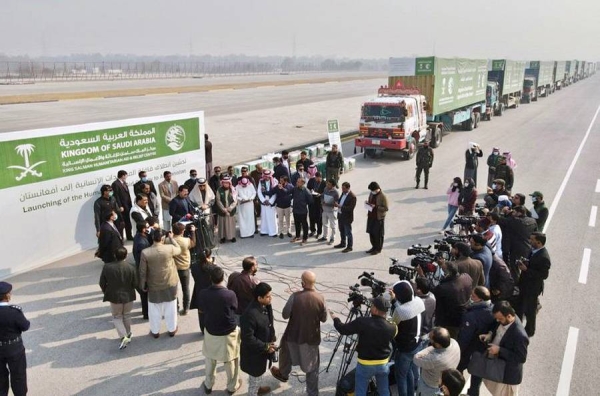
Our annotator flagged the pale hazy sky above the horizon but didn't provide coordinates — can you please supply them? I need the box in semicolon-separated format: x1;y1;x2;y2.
0;0;600;60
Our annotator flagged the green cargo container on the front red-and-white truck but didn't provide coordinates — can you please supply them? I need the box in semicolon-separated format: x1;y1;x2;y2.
388;56;488;116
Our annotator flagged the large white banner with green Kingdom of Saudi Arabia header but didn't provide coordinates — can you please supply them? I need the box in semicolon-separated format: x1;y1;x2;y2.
0;112;206;279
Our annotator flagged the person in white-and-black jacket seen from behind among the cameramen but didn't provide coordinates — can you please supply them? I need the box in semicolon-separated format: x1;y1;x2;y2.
390;280;425;396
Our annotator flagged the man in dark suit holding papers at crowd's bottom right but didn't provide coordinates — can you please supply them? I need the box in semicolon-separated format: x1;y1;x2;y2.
479;301;529;395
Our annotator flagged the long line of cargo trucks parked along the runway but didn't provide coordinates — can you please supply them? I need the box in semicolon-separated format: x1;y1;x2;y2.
354;57;596;159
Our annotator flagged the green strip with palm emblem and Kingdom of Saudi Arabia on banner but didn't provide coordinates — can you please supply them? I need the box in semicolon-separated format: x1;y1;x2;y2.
0;118;200;189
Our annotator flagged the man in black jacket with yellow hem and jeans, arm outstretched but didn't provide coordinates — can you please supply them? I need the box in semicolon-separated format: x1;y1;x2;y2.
329;296;398;396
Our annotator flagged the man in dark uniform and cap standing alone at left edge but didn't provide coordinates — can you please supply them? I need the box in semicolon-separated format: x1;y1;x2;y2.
0;282;29;396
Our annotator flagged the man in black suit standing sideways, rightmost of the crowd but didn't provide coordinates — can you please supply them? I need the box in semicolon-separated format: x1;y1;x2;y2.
516;231;550;337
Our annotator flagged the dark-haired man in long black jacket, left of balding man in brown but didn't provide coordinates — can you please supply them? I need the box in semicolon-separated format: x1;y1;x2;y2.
240;282;276;396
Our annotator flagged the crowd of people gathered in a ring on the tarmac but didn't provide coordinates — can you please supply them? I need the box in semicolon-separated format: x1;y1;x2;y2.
48;136;550;396
